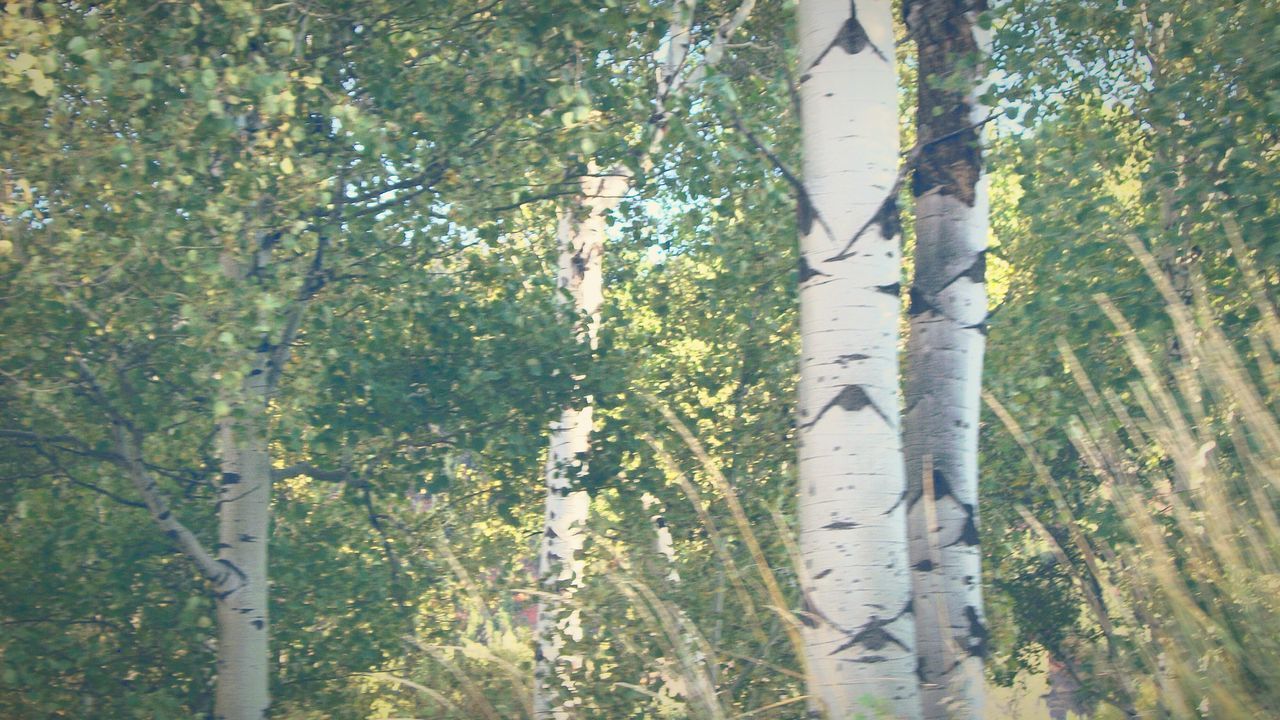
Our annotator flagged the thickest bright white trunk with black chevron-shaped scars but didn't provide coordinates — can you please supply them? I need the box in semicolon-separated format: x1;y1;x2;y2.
796;0;920;720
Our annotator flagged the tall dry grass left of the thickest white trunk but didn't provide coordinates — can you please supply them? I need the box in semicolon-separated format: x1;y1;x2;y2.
364;397;808;720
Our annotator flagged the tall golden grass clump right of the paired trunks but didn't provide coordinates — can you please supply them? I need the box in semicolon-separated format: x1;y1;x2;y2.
986;228;1280;719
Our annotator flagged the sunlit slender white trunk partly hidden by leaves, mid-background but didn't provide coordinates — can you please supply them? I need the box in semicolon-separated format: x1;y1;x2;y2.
534;169;630;719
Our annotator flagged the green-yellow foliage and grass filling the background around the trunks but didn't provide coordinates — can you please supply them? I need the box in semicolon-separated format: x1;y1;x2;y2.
0;0;1280;719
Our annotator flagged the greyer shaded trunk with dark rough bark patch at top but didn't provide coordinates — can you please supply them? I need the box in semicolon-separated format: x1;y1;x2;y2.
904;0;988;720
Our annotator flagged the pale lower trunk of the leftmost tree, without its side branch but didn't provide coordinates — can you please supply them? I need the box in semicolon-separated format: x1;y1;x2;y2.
214;351;271;720
